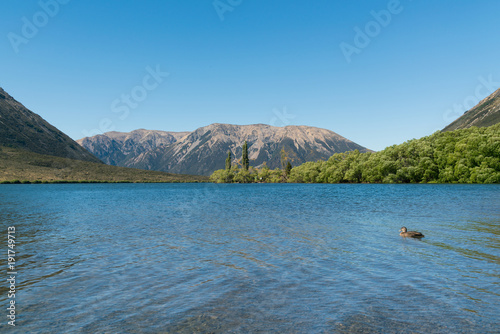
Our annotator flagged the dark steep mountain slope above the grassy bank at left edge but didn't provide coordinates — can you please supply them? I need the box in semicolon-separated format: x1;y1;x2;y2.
0;88;101;162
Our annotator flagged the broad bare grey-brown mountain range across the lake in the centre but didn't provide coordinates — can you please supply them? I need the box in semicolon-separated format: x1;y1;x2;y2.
78;124;368;175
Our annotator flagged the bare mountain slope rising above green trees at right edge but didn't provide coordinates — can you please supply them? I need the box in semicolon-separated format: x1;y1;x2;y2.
443;89;500;131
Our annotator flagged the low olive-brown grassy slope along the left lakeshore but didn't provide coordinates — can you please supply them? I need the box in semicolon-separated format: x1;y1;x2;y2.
0;146;208;183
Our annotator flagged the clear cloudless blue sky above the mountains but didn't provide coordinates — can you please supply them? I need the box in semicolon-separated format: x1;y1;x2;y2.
0;0;500;150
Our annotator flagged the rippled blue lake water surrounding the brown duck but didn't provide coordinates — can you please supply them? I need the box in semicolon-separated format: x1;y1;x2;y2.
0;184;500;333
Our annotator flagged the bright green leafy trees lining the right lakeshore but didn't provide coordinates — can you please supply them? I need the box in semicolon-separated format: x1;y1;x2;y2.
210;124;500;183
